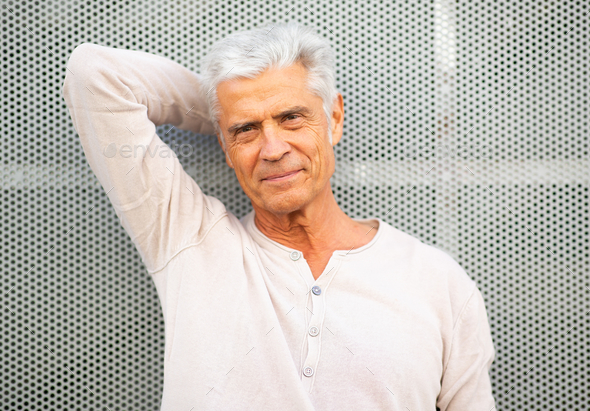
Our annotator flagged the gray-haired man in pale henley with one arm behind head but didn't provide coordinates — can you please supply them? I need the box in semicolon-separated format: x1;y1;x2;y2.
64;23;494;411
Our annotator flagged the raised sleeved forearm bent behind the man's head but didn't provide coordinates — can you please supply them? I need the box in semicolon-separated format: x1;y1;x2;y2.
63;43;214;134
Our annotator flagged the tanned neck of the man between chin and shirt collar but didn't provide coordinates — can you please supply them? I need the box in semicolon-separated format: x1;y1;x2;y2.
254;183;358;255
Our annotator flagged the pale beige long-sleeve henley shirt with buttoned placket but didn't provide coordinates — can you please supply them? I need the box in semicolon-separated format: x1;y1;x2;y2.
63;44;494;411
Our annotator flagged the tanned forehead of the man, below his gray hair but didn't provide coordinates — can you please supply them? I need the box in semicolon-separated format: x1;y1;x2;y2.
217;63;321;124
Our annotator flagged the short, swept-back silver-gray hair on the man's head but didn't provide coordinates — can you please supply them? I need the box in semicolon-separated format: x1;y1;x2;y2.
202;21;337;148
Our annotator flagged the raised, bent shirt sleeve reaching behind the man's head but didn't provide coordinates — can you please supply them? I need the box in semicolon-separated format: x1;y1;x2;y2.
63;43;225;273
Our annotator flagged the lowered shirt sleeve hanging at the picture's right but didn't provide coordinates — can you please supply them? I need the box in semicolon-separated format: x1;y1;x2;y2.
436;286;495;411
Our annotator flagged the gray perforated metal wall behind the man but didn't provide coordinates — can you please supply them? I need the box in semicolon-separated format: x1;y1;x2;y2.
0;0;590;411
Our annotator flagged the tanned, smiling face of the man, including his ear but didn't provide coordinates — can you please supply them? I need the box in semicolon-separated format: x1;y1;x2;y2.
217;64;344;215
